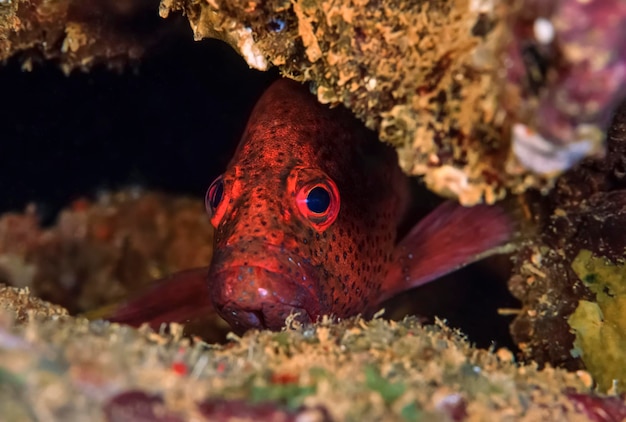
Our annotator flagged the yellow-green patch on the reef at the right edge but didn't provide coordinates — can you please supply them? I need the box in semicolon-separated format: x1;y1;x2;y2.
568;249;626;391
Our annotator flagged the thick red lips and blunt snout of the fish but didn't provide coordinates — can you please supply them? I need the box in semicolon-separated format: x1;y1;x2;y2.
209;244;321;331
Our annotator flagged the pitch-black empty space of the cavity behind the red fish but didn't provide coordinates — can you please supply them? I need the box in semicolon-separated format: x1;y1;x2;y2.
0;24;516;347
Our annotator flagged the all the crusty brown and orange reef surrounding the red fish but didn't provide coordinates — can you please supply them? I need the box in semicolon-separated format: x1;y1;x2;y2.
0;0;626;421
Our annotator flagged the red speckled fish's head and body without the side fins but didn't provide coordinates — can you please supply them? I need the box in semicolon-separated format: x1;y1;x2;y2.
200;81;400;331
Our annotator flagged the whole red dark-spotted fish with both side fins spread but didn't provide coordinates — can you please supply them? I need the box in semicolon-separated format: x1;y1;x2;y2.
109;79;514;331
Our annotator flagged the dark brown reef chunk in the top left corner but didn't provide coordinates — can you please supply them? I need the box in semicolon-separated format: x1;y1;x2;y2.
0;0;171;73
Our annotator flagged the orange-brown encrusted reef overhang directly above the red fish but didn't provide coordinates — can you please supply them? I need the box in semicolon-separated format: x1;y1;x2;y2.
161;0;507;203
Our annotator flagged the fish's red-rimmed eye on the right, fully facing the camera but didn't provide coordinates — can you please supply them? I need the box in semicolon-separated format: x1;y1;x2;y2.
296;179;339;231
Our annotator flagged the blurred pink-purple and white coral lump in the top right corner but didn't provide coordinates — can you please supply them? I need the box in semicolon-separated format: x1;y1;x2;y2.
502;0;626;173
